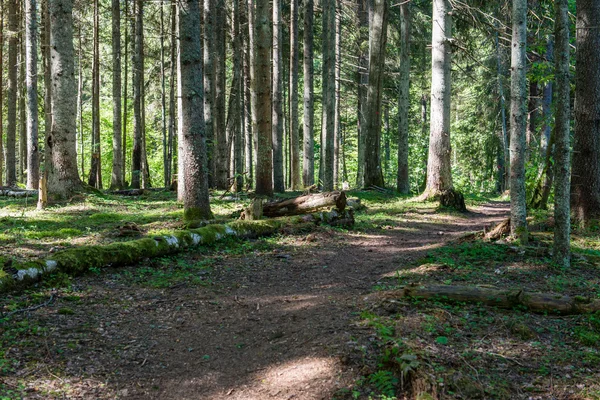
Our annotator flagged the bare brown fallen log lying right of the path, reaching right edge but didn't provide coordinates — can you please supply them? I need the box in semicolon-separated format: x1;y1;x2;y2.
384;284;600;315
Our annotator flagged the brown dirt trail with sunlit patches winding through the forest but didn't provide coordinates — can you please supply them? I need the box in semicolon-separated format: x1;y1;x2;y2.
5;203;508;400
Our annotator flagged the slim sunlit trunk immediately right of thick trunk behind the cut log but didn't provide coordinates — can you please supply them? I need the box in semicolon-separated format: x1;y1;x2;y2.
271;0;285;193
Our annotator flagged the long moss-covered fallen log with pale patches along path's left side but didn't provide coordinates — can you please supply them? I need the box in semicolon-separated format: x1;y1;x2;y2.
0;211;354;293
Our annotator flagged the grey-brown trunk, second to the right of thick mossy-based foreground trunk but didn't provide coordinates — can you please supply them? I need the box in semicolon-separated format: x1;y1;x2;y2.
213;0;229;189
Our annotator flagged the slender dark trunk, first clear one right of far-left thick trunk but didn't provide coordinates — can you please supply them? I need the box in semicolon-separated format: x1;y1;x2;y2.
88;0;102;189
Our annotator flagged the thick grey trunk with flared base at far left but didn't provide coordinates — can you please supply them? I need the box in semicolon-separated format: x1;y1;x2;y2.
47;0;81;200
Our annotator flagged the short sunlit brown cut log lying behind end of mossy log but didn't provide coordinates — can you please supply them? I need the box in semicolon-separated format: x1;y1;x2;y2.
263;192;346;218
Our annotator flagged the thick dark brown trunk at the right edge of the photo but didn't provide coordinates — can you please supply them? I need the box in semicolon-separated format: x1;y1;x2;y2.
571;0;600;227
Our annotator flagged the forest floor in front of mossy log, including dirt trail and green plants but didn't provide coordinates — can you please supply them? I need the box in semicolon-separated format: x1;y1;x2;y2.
0;193;600;400
